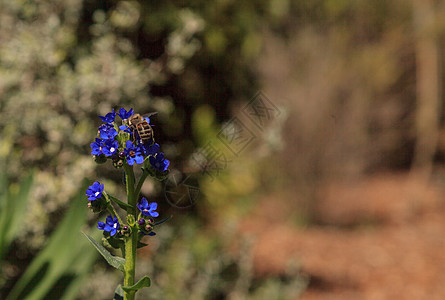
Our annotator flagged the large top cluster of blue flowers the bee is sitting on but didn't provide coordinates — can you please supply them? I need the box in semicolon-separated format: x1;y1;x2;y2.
90;108;170;172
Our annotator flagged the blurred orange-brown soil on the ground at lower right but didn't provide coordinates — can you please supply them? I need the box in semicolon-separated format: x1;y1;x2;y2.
240;175;445;300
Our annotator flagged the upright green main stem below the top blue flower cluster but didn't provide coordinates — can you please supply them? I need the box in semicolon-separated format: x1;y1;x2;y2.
124;162;137;300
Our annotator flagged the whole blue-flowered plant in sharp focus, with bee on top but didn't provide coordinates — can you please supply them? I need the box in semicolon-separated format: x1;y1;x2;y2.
85;108;170;300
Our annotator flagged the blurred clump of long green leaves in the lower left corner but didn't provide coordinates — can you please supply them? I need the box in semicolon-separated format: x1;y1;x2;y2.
0;173;98;300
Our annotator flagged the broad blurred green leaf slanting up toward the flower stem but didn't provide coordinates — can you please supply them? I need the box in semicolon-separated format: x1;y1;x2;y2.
6;182;100;300
